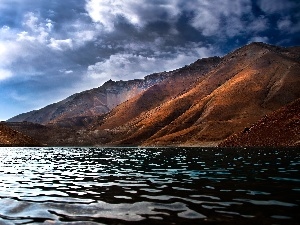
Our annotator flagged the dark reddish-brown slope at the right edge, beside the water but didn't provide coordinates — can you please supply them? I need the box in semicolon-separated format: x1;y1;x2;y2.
219;99;300;147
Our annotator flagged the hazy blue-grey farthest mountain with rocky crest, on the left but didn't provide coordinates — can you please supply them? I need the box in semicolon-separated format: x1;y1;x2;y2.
7;72;169;124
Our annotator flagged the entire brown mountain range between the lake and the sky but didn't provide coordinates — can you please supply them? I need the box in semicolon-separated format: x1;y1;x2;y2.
2;43;300;147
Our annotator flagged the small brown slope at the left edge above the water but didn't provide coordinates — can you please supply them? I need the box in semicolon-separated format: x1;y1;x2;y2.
0;123;41;147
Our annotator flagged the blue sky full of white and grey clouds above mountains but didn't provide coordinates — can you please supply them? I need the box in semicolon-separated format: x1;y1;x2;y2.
0;0;300;120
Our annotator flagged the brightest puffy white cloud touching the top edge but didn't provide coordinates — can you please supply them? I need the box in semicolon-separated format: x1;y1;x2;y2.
86;0;181;31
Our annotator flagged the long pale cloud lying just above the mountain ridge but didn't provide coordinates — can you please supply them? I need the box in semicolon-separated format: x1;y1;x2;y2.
87;44;213;81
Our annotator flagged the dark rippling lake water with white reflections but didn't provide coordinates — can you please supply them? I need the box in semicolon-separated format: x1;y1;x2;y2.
0;148;300;225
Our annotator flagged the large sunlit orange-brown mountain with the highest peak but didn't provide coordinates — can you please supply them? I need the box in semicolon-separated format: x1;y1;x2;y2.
92;43;300;145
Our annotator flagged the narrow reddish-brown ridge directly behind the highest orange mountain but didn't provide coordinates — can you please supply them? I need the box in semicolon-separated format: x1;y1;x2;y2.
94;57;220;129
